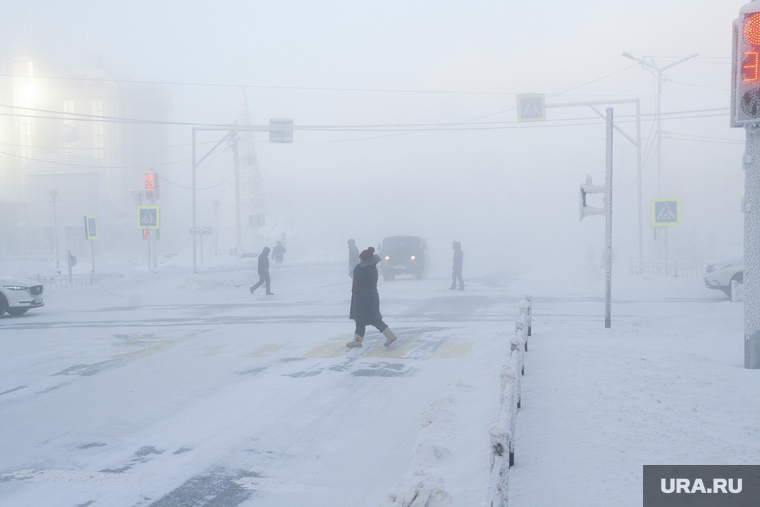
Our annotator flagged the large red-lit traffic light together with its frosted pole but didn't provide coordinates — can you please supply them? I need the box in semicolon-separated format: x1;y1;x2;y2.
731;2;760;369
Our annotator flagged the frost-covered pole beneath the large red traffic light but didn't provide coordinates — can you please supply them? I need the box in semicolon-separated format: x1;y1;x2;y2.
744;123;760;369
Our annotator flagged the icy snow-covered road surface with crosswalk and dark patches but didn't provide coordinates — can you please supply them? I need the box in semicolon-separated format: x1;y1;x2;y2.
0;265;522;507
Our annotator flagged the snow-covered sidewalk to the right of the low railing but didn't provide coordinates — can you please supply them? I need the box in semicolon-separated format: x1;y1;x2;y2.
509;279;760;507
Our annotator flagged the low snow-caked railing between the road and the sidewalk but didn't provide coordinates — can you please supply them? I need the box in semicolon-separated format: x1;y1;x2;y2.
485;296;533;507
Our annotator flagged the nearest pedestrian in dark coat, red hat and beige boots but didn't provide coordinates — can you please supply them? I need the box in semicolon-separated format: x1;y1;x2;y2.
346;247;396;347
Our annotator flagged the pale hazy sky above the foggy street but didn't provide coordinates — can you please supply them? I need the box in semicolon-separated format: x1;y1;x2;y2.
0;0;745;276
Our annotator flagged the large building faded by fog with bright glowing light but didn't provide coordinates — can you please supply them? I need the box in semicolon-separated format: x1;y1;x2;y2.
0;40;170;266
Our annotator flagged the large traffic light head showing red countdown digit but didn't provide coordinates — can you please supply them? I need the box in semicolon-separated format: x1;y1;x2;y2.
731;7;760;127
